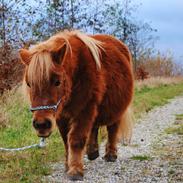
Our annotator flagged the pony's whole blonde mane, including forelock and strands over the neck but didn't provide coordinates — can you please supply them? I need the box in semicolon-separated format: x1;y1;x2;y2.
27;31;103;88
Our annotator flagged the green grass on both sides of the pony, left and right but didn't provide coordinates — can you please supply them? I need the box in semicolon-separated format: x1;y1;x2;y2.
0;80;183;183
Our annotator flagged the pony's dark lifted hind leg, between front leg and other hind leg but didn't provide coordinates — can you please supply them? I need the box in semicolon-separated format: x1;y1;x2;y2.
87;127;99;160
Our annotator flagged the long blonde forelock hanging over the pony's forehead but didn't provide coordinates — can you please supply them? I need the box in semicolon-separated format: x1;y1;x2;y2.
27;51;52;90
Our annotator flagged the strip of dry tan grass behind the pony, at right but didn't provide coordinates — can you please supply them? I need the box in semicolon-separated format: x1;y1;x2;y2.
135;77;183;91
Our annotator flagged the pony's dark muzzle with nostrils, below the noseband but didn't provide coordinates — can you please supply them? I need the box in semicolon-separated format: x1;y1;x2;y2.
33;119;52;137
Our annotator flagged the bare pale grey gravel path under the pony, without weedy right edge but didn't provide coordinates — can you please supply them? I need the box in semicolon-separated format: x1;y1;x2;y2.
46;96;183;183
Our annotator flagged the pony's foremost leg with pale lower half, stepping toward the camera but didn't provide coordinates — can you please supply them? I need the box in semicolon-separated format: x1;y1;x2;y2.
67;103;96;180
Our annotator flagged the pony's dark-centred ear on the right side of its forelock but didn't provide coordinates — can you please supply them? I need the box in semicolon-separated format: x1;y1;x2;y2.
51;44;67;64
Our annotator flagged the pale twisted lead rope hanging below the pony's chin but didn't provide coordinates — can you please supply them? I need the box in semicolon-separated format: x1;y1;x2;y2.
0;138;46;152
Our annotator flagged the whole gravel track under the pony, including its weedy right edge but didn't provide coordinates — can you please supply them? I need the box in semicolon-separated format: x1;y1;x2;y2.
44;97;183;183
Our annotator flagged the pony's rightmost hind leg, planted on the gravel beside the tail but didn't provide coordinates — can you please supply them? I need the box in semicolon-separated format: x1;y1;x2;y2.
104;123;120;162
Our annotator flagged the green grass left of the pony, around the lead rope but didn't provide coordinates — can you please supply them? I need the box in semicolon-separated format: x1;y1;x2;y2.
0;89;64;183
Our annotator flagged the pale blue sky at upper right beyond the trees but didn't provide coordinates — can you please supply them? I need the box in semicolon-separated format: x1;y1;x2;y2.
133;0;183;62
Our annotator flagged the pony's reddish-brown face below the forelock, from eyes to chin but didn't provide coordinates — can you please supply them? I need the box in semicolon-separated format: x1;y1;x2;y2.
25;71;65;137
